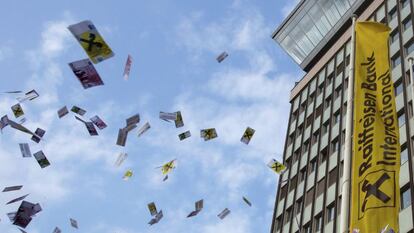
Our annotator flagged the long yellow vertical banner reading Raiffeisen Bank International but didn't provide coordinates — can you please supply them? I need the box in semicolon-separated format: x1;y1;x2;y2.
350;22;400;233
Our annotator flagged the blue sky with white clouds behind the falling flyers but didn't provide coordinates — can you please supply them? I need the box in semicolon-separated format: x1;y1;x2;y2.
0;0;302;233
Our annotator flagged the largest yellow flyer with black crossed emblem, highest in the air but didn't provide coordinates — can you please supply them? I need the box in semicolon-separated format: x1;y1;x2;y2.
68;20;114;64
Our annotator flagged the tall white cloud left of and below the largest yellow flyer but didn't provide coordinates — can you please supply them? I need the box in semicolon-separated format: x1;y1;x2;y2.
0;14;116;208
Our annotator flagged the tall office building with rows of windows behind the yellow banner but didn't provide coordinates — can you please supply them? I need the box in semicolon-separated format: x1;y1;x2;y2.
271;0;414;233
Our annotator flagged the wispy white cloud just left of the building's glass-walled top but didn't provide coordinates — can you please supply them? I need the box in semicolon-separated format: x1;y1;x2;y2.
176;8;271;64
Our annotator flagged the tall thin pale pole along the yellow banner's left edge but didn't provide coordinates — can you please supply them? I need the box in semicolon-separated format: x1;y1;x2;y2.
339;15;356;233
